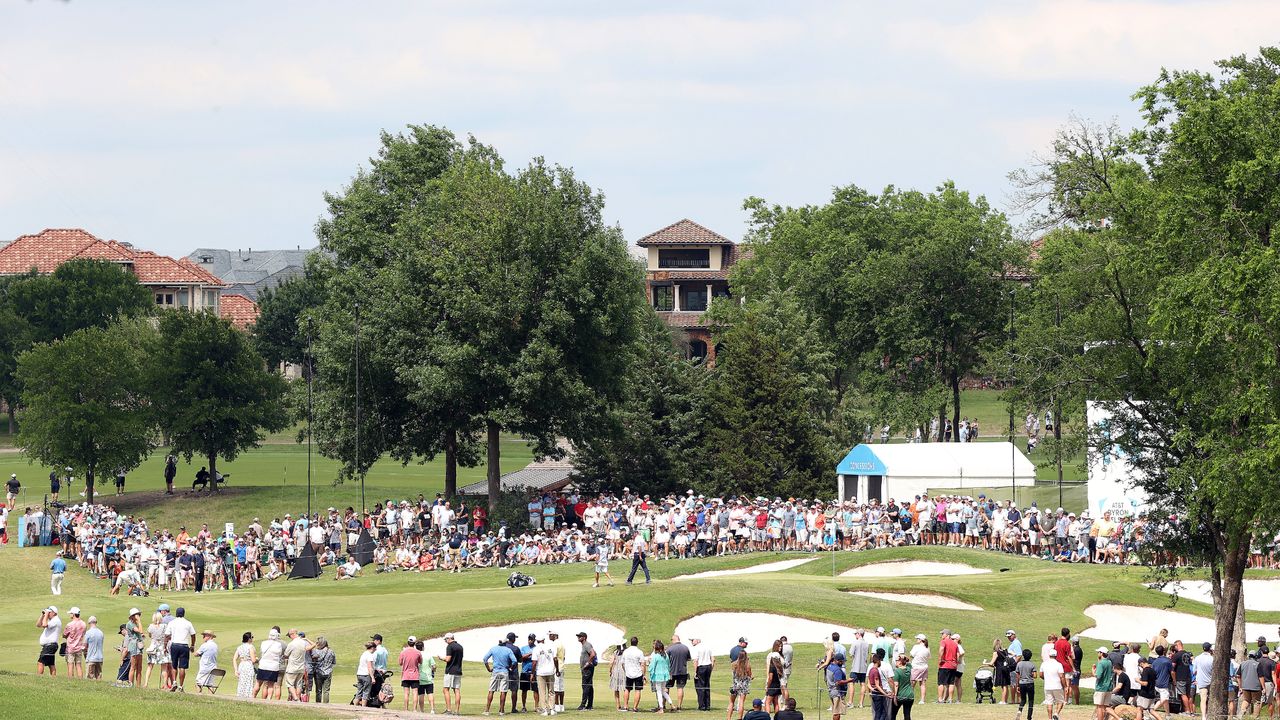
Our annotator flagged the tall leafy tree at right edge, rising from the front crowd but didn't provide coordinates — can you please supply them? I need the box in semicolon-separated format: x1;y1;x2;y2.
1018;47;1280;716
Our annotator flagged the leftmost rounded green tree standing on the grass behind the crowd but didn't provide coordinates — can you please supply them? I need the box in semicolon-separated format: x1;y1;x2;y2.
18;323;155;502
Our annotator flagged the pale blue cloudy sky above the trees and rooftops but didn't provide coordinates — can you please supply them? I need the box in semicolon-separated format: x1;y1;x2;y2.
0;0;1280;255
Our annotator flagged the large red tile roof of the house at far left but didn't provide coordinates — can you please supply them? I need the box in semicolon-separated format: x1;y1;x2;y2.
0;228;223;287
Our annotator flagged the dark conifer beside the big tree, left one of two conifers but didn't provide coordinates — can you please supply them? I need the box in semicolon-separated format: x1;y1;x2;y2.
573;307;710;496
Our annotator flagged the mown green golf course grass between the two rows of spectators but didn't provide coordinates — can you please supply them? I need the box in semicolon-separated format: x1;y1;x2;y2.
0;538;1264;720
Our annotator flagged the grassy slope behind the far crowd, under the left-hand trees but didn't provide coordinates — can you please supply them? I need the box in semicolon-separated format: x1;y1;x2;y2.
0;433;531;532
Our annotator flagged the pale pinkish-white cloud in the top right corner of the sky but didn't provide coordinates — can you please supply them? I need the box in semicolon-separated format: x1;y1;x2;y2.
888;0;1280;85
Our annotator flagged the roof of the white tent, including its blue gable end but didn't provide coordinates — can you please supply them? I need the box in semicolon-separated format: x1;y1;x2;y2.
836;442;1036;478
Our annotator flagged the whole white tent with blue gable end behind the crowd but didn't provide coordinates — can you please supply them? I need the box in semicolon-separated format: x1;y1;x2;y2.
836;442;1036;502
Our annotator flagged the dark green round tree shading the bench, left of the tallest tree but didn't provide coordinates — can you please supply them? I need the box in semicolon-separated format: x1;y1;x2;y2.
150;310;288;491
